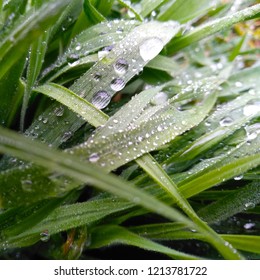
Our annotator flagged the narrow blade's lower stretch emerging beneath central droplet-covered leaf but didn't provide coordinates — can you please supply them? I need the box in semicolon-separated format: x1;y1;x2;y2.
136;154;242;258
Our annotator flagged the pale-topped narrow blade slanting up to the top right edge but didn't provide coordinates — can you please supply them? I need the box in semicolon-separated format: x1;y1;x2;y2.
167;4;260;54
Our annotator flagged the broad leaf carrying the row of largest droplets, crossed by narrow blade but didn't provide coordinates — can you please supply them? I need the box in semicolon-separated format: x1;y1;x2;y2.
19;22;179;150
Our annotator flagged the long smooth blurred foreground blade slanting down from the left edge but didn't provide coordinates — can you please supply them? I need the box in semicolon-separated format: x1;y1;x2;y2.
0;128;196;227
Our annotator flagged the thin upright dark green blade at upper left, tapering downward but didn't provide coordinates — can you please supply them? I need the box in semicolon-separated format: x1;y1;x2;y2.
20;31;50;131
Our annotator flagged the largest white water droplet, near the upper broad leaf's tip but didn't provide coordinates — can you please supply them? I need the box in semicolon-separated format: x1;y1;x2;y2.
139;37;163;61
